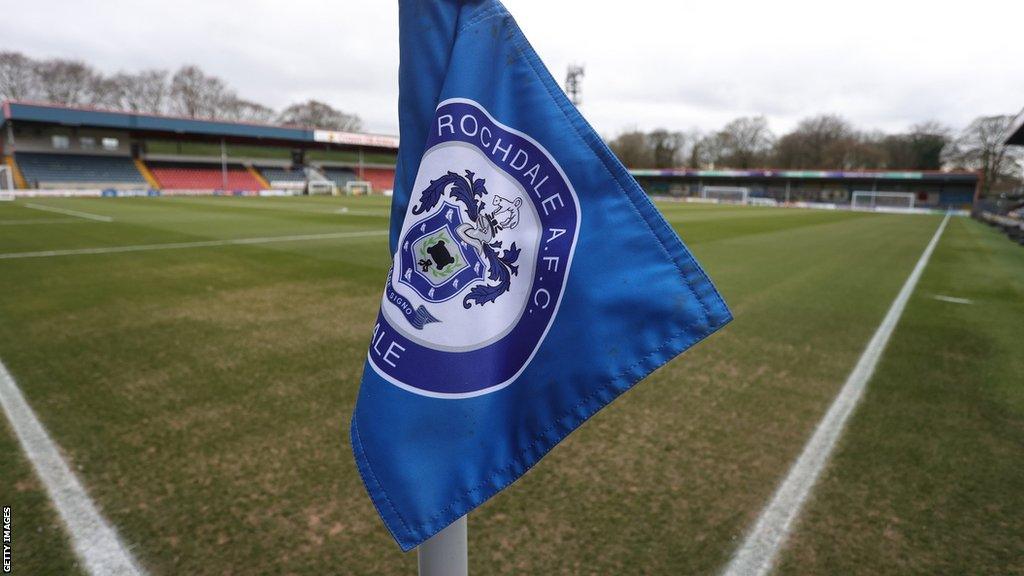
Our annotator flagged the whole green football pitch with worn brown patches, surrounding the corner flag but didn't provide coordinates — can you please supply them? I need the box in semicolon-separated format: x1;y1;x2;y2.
0;197;1024;575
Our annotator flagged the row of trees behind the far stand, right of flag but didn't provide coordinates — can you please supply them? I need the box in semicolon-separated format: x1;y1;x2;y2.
608;115;1024;192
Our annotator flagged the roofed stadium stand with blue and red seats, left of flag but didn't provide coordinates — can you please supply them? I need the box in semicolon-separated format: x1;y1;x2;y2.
0;100;398;195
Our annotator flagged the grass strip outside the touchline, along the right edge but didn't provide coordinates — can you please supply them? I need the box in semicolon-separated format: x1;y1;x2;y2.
781;219;1024;574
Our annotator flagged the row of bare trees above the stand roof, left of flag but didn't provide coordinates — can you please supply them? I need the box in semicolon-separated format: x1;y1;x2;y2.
0;51;362;131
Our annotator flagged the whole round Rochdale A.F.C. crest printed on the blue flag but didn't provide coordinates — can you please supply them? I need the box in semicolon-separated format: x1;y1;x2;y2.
370;99;580;398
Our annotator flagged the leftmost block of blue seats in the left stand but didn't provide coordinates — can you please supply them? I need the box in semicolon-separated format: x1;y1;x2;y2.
14;152;148;188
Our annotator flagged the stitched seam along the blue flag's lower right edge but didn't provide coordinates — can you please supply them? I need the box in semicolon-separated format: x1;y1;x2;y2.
417;319;715;525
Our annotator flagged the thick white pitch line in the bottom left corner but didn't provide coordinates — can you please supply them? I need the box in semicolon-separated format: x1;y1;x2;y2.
0;362;145;576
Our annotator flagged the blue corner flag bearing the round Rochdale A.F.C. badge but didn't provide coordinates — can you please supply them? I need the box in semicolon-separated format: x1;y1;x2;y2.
351;0;731;550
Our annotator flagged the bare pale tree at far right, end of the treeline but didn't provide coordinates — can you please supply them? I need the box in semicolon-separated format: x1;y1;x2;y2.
942;116;1024;195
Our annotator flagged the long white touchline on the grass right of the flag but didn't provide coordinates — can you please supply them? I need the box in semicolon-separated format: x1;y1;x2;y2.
723;213;949;576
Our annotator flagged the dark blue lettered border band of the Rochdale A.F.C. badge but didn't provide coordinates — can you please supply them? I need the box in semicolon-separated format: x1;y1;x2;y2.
368;98;580;399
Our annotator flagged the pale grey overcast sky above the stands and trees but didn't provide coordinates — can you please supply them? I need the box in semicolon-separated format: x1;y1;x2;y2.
0;0;1024;135
